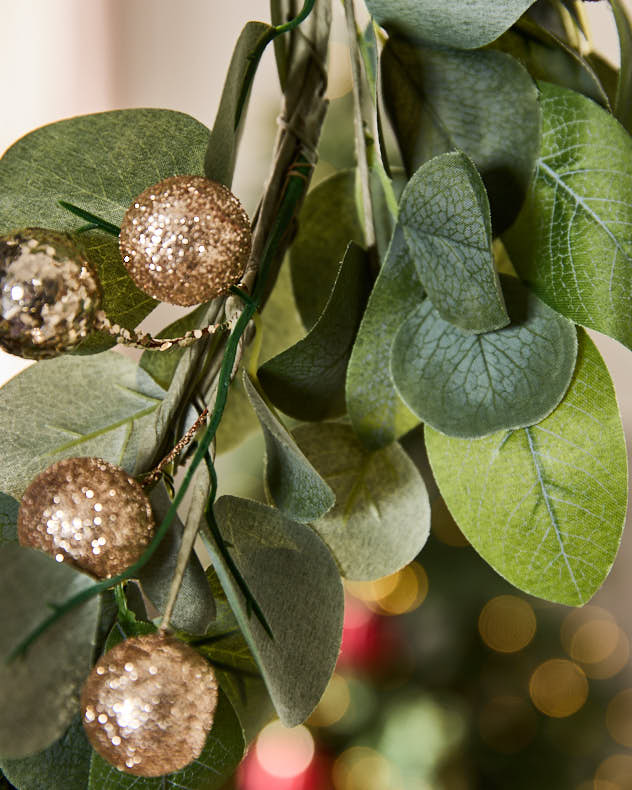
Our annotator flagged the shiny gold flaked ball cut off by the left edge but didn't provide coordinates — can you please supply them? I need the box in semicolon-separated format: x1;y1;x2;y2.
0;228;101;359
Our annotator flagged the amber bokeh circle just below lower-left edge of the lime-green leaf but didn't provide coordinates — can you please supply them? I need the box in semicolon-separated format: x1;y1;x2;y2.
478;595;537;653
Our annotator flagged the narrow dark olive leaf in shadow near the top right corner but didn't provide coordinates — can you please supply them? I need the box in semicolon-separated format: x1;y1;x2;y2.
491;18;610;109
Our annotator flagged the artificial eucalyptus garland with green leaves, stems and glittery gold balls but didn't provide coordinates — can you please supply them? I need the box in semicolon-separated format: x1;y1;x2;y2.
0;0;632;790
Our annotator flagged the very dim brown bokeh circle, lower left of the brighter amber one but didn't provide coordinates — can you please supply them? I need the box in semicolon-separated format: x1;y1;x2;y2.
478;696;538;754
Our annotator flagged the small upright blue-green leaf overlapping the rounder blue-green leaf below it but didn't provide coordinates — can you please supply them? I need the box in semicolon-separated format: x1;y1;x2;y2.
399;152;509;332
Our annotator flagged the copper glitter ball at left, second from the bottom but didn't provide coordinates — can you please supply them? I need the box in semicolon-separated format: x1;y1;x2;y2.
18;458;155;579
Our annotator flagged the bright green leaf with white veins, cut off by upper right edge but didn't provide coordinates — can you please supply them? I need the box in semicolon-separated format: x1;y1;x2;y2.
505;83;632;347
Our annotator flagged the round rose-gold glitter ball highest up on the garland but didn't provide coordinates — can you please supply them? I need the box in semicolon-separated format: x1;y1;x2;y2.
119;176;252;306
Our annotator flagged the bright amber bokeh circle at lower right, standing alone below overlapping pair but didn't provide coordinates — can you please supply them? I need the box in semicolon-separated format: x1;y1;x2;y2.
529;658;588;719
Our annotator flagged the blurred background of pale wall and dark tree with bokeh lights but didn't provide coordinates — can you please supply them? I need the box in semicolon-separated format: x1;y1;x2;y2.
0;0;632;790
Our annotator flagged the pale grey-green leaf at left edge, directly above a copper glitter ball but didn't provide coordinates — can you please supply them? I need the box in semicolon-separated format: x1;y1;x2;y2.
0;351;164;498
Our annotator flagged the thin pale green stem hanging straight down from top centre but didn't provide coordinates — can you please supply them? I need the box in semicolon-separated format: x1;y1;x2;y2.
344;0;377;255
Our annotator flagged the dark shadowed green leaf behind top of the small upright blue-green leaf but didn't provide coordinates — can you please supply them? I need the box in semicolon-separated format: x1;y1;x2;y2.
382;40;540;233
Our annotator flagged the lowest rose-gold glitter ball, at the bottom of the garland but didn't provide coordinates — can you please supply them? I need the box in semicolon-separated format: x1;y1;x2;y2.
81;634;217;776
